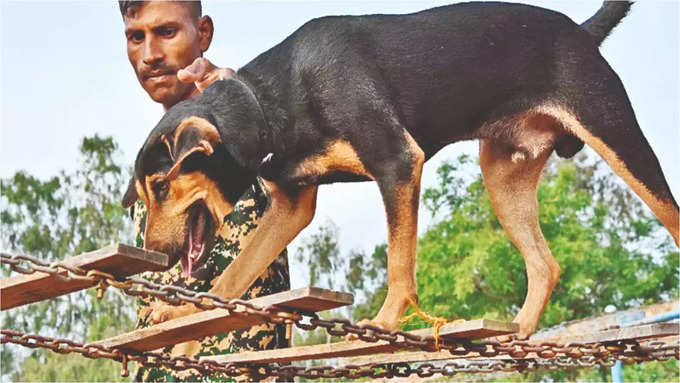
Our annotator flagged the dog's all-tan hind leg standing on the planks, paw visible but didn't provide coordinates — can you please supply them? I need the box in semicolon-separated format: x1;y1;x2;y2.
479;140;560;338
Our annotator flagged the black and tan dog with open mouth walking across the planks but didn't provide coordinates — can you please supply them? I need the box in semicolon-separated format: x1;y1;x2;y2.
124;2;678;337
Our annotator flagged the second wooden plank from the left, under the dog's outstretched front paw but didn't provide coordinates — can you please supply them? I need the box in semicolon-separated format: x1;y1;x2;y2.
97;287;354;351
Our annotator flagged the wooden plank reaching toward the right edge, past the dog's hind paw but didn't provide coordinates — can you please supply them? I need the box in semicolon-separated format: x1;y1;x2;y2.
340;323;680;366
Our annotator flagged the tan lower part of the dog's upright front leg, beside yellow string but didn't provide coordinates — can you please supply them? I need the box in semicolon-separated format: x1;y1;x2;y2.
372;132;425;330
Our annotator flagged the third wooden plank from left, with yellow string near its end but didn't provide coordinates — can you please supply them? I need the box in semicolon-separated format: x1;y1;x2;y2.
202;319;519;363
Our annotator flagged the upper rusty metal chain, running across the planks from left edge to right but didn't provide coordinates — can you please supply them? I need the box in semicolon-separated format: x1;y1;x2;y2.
0;254;680;376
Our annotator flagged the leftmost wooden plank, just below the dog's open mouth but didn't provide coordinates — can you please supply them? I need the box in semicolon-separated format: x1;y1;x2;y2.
0;244;168;310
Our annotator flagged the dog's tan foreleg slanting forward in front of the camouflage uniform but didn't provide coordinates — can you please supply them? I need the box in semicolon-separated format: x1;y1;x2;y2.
210;181;318;299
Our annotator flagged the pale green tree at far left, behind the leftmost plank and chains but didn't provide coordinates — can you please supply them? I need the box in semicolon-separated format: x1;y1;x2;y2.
0;136;135;381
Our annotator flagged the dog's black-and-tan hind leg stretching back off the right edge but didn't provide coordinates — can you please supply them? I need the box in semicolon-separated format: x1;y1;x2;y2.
548;57;680;246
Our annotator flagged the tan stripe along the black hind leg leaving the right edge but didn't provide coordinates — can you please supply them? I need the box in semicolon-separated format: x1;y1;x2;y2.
536;103;680;246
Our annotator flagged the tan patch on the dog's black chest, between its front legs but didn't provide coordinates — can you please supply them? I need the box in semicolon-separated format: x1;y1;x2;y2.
296;140;373;178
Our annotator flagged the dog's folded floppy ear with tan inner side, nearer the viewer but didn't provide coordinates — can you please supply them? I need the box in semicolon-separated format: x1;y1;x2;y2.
161;116;221;179
